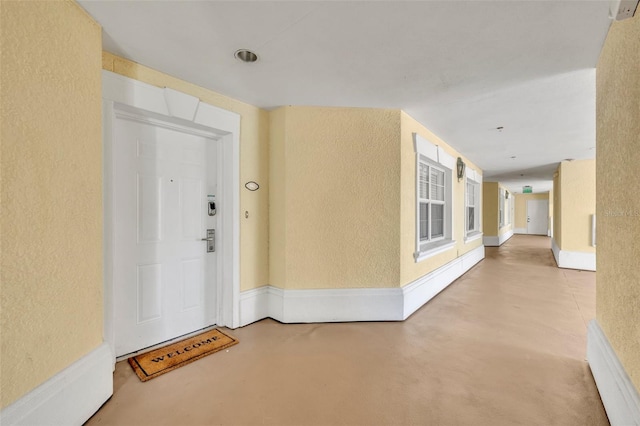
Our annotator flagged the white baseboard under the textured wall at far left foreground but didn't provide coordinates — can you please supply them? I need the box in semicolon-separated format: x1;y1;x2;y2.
0;343;113;426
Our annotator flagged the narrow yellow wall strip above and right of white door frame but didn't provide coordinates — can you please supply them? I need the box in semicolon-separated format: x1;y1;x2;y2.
102;52;269;290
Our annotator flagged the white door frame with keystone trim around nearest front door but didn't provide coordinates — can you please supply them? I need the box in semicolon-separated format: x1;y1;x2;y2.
102;70;240;366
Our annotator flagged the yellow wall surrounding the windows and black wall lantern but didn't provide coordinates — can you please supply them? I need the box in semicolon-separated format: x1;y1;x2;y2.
400;112;482;286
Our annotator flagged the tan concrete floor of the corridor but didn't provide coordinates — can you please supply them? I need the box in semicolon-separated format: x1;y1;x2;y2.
87;235;608;426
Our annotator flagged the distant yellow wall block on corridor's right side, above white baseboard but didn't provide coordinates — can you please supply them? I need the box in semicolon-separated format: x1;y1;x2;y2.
556;160;596;253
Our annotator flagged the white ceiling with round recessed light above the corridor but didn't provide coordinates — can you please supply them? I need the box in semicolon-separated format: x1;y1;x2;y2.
80;0;611;192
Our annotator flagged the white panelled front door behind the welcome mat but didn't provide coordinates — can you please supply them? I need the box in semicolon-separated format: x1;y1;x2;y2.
113;118;219;356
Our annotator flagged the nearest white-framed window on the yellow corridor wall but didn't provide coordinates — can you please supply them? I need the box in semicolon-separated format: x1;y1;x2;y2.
414;134;455;262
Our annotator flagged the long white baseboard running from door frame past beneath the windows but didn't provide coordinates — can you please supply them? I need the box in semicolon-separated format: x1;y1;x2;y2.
240;246;484;326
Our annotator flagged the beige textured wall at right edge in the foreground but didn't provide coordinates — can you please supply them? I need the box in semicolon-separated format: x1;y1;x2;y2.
596;12;640;392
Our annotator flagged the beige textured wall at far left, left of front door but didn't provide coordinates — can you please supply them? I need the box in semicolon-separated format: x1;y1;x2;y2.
0;1;102;407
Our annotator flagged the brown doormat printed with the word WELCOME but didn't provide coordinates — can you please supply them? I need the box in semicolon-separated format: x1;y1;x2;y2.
128;329;238;382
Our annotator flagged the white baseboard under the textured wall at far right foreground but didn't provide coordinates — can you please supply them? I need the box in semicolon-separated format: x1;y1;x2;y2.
587;320;640;426
